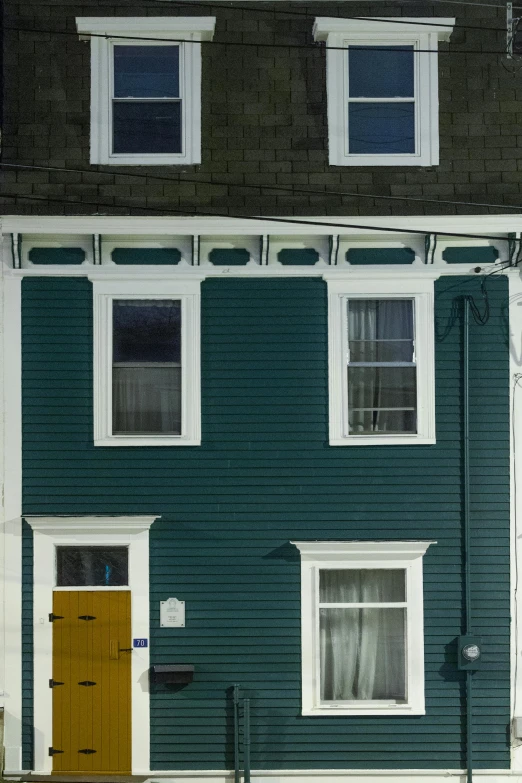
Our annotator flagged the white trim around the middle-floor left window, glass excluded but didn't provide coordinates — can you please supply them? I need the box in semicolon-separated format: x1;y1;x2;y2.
93;278;201;446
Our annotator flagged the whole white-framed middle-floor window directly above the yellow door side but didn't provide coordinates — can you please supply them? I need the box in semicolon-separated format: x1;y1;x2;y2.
94;281;201;446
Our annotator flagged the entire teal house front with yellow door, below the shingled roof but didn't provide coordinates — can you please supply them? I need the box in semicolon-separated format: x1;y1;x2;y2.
3;211;520;782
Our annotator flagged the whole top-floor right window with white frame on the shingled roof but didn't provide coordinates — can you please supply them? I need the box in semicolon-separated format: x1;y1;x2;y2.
314;18;454;166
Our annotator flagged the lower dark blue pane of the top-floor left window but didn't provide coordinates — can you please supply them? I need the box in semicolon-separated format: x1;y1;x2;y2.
112;101;181;154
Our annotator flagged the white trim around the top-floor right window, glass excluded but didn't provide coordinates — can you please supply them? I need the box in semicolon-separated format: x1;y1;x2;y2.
314;17;455;166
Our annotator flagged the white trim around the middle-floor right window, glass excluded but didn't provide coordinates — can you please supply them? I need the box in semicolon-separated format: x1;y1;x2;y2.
325;275;436;446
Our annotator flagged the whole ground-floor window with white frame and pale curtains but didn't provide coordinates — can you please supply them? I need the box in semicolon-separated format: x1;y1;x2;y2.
294;541;430;715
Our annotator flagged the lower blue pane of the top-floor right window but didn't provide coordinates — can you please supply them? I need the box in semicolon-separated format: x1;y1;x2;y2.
348;102;415;155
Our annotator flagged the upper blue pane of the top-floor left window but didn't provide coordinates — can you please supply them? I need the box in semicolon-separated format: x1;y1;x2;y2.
114;46;179;98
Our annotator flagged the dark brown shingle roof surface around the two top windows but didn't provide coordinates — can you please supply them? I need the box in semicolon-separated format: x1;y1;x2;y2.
0;0;522;215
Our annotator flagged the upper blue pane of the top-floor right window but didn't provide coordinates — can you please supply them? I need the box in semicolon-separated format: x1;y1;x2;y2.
348;46;413;98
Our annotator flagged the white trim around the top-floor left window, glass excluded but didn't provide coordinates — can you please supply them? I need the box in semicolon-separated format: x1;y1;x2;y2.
76;16;216;166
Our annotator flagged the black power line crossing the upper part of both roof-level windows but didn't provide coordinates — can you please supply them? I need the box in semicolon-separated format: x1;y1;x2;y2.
4;23;505;56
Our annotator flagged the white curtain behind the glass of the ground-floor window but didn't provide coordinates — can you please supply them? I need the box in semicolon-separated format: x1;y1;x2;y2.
319;570;406;701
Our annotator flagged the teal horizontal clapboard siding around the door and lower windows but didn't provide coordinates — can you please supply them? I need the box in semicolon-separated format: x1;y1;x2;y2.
23;277;509;769
